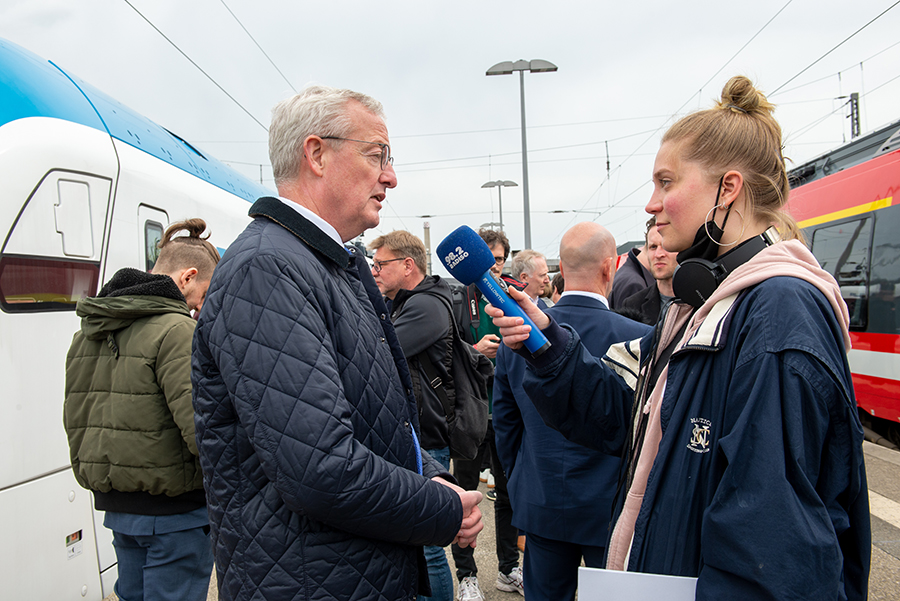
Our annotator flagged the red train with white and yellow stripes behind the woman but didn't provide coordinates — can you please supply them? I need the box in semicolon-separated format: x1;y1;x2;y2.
788;121;900;445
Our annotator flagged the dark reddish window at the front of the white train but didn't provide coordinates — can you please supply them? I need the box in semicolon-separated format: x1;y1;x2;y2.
0;255;100;313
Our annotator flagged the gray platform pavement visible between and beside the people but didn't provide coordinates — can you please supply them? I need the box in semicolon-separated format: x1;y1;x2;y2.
104;442;900;601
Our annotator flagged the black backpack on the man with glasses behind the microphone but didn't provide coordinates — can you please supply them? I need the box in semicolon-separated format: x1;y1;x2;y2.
417;294;494;460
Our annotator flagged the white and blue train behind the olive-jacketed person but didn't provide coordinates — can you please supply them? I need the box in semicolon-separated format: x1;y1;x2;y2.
0;40;272;600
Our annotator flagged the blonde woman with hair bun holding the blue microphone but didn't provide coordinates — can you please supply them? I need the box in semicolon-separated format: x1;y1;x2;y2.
489;77;871;601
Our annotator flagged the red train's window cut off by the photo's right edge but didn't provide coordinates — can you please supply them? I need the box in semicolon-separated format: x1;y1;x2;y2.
868;206;900;334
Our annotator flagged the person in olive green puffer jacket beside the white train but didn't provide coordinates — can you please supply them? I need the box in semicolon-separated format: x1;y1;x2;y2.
63;219;219;601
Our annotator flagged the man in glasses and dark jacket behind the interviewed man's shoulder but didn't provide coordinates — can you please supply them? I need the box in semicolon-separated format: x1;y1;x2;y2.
369;230;453;601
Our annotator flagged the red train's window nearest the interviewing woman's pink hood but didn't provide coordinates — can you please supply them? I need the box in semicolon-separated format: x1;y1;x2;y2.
812;217;872;330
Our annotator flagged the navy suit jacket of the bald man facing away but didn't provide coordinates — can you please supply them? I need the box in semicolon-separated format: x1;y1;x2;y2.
494;294;650;547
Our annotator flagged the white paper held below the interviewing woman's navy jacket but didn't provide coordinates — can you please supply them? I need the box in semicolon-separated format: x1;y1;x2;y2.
578;568;697;601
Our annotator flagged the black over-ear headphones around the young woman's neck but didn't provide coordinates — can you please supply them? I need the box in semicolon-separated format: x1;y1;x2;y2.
672;227;781;307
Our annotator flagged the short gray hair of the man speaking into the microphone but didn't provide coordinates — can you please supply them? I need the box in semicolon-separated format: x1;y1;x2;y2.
269;86;384;185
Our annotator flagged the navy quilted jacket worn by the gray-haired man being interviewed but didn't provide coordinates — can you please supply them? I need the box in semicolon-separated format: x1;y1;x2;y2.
192;198;462;601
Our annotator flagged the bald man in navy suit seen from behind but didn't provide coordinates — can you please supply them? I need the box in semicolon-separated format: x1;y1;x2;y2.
494;222;650;601
